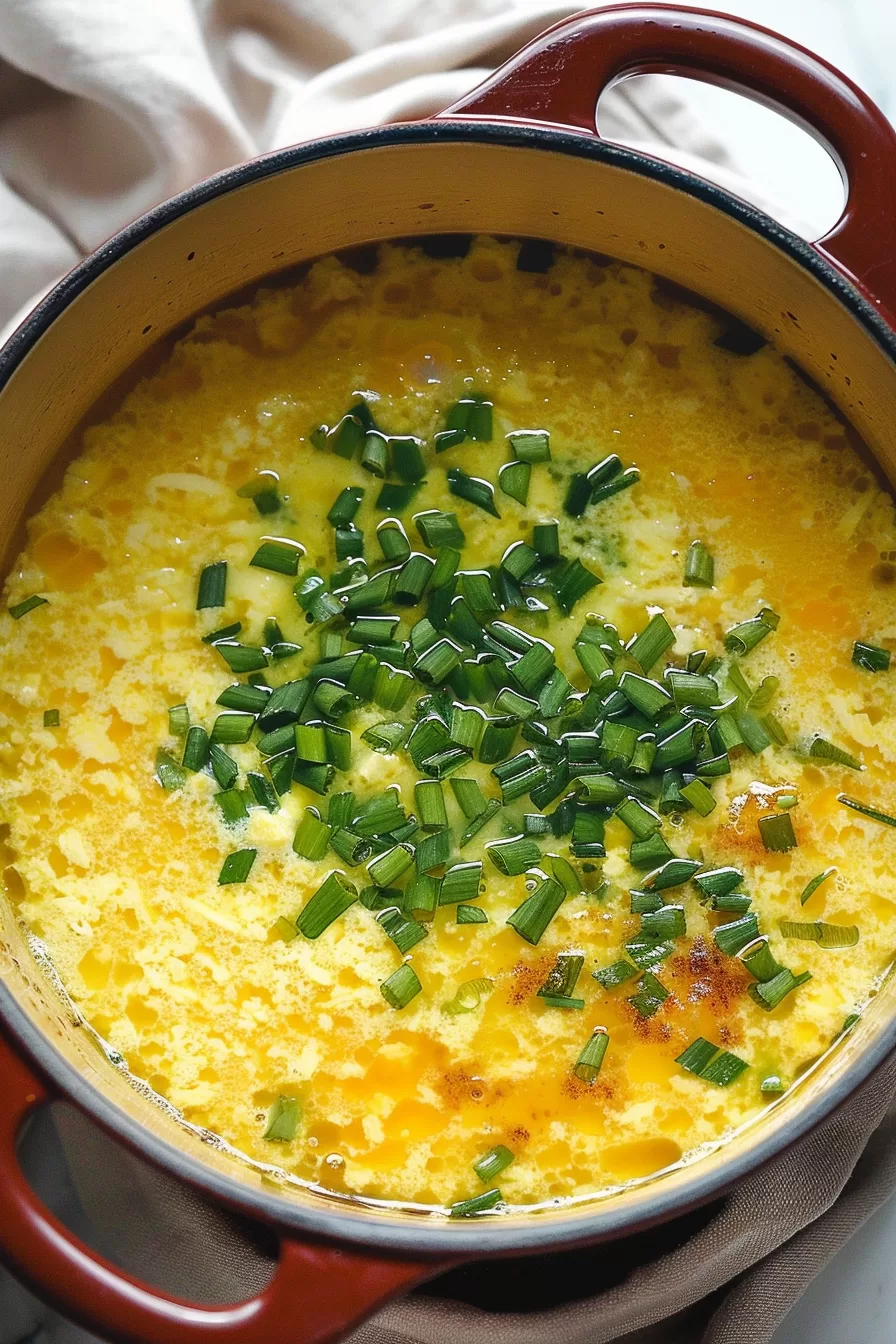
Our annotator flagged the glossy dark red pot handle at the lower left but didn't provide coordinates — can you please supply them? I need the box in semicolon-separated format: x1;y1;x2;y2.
0;1038;435;1344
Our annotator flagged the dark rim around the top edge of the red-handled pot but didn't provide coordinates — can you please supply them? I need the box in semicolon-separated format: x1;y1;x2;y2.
0;120;896;1257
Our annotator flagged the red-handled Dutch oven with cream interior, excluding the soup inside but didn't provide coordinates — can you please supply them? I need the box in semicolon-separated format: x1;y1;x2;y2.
0;4;896;1344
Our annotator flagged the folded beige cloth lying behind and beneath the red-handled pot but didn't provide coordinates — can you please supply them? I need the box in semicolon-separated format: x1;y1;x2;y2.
0;0;896;1344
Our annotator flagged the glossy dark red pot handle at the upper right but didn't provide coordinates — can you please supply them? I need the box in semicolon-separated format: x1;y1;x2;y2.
439;4;896;327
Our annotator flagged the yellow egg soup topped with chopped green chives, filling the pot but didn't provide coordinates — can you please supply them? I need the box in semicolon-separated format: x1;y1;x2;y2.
0;238;896;1216
